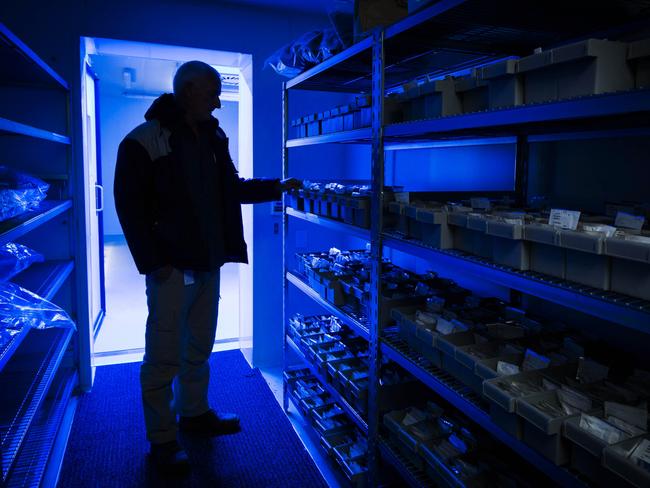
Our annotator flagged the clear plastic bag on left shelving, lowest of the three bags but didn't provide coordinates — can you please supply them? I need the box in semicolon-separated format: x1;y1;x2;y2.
0;282;76;329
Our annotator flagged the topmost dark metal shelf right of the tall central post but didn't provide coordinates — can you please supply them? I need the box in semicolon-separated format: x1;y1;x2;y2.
384;0;650;87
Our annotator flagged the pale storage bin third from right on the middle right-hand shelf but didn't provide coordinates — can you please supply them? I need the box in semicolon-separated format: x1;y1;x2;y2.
524;223;566;279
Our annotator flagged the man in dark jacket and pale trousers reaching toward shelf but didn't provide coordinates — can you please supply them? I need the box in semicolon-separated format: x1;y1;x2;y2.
114;61;300;473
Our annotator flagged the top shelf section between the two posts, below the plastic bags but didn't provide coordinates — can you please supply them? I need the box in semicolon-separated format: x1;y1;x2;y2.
286;37;372;92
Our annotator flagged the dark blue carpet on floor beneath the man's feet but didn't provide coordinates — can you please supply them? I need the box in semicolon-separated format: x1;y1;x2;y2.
58;351;327;488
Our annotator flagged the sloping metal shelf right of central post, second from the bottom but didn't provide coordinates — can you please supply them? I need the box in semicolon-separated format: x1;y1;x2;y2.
381;334;584;486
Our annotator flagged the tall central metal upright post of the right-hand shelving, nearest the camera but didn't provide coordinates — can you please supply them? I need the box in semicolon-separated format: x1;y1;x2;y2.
368;29;384;486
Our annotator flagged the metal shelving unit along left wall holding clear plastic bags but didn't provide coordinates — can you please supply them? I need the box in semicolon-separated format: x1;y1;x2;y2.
0;23;78;487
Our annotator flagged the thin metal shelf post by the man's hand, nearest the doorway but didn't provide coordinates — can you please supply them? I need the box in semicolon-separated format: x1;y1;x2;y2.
282;82;289;412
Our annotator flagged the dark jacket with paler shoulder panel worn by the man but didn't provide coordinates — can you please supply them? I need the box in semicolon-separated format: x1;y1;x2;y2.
114;94;281;274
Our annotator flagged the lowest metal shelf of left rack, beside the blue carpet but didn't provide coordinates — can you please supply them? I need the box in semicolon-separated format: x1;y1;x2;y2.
6;368;78;488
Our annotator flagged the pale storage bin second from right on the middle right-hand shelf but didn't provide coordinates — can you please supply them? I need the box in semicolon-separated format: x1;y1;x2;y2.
558;230;611;290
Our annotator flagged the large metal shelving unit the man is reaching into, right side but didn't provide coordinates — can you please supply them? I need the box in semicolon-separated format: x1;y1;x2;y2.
283;0;650;486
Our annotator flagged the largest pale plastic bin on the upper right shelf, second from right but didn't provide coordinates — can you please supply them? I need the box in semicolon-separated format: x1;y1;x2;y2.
518;39;634;103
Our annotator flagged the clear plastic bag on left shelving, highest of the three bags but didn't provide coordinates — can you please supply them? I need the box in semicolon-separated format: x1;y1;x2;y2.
0;166;50;221
